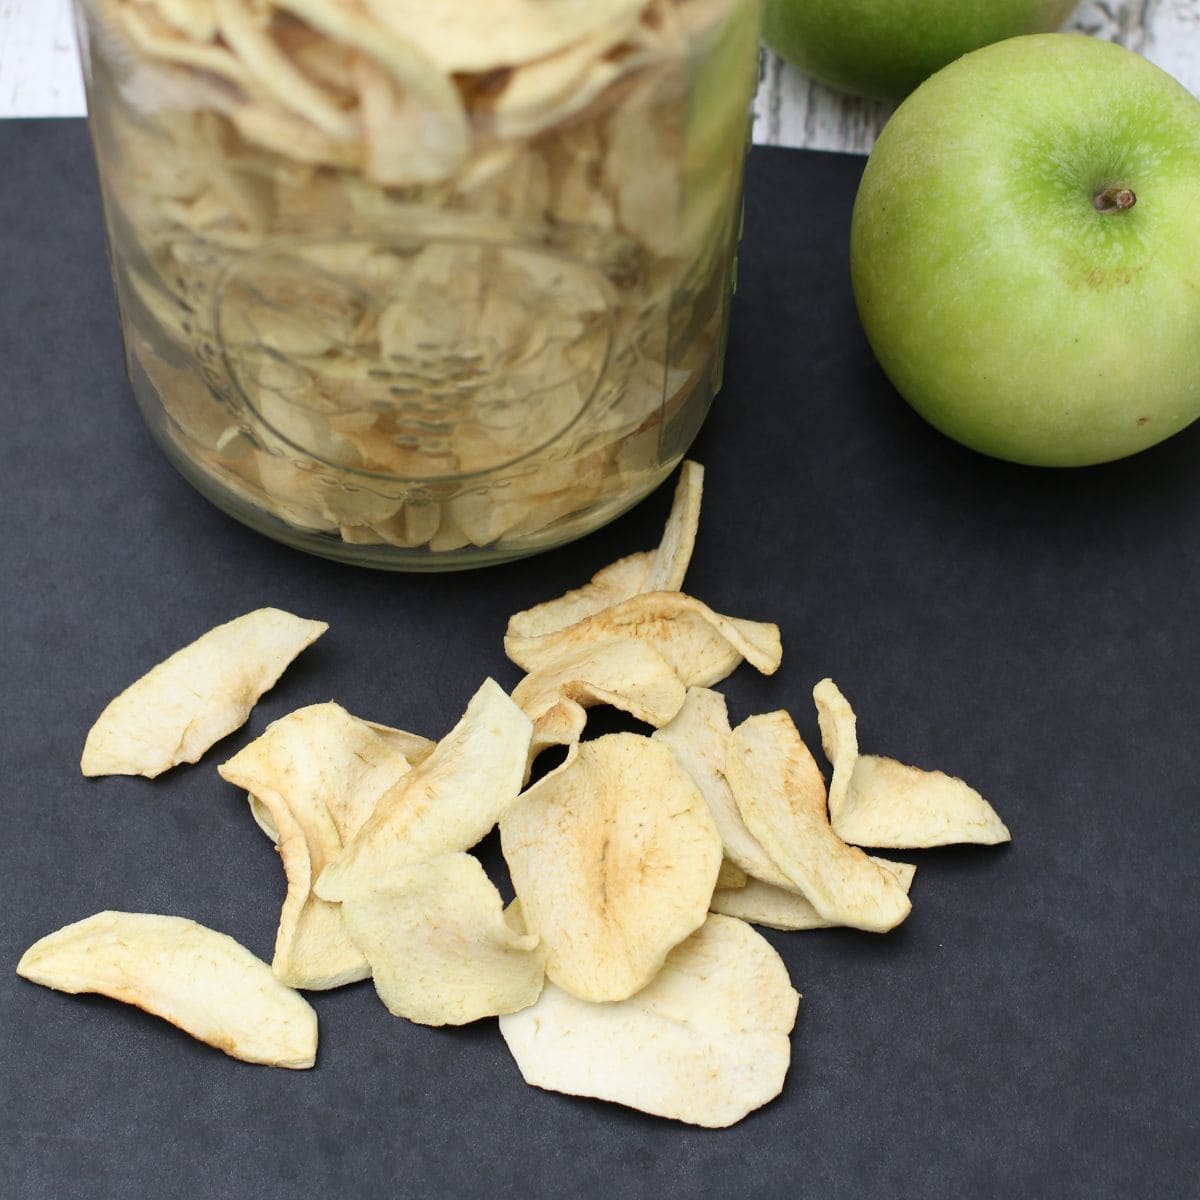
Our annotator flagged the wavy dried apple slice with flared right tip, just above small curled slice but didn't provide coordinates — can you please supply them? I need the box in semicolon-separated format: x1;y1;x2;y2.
504;592;782;688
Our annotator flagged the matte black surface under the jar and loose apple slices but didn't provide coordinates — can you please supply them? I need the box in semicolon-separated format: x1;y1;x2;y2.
0;121;1200;1200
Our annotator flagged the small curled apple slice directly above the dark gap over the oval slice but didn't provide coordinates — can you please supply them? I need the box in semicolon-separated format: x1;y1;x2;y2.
512;637;685;751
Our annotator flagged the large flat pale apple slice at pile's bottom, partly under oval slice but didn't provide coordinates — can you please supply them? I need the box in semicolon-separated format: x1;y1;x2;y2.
500;916;799;1128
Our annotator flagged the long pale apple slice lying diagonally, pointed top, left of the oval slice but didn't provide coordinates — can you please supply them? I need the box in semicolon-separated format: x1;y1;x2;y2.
314;679;533;900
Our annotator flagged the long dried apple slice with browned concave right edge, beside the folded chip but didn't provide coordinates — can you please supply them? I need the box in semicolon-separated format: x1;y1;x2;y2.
725;712;912;934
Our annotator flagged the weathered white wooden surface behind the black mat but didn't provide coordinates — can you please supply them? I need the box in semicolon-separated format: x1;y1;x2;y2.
0;0;1200;154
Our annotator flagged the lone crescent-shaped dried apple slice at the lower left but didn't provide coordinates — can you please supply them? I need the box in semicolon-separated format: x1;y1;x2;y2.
17;912;317;1069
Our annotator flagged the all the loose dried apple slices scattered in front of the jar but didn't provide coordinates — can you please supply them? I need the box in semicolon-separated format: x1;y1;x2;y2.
18;462;1009;1127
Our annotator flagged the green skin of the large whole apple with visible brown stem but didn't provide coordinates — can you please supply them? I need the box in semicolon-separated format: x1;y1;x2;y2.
850;34;1200;466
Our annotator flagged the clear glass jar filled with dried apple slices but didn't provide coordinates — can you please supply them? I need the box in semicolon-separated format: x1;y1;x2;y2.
76;0;760;570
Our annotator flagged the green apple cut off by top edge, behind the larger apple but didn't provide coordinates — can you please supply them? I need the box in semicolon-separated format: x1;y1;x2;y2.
762;0;1076;100
